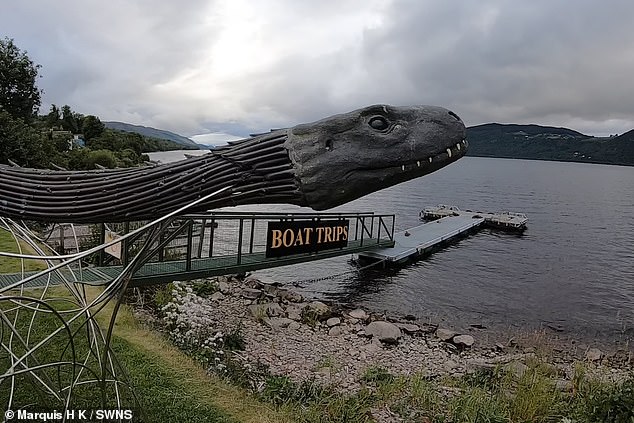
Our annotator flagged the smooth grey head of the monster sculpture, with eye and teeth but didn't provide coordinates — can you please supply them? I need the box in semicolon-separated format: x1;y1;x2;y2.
284;105;467;210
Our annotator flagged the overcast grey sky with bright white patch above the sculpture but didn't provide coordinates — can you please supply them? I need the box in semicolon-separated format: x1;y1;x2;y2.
0;0;634;136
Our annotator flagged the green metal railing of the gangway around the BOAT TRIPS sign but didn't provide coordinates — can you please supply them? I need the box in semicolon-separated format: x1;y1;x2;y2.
97;211;395;271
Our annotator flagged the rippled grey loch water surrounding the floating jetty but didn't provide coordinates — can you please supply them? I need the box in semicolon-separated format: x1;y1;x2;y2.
149;152;634;340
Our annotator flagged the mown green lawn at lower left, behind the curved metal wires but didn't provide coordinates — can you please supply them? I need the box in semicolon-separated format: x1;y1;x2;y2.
0;288;292;423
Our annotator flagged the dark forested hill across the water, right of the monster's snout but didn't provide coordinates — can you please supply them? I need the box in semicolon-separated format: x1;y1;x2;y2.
467;123;634;166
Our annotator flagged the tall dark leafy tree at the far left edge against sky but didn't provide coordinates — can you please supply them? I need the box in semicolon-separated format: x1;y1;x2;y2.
0;38;41;122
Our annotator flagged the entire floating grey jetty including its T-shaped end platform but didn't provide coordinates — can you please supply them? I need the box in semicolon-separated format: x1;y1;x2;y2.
358;205;528;264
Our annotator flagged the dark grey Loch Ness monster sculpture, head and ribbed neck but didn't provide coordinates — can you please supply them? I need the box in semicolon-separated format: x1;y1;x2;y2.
0;105;467;223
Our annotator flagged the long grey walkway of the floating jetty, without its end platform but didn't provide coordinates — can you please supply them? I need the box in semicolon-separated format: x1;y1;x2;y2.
359;216;484;263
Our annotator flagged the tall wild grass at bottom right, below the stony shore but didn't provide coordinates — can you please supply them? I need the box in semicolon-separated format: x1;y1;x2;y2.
346;360;634;423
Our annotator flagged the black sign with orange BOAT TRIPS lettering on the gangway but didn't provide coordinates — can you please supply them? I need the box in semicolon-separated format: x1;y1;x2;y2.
266;219;350;257
